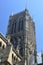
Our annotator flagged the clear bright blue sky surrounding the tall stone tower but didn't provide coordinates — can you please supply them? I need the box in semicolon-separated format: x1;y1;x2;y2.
0;0;43;52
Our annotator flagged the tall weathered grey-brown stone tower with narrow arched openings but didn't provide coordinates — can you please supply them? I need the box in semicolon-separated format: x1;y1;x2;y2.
6;9;36;65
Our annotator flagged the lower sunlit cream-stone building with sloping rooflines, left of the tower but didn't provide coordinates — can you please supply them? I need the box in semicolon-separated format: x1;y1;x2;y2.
0;33;21;65
